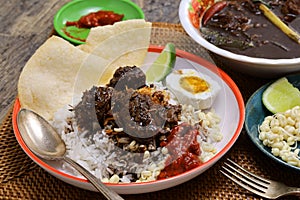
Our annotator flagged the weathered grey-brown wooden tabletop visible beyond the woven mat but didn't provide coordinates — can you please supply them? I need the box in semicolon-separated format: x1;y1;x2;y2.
0;0;180;122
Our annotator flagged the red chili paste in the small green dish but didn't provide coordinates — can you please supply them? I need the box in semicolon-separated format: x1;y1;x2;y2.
66;10;124;28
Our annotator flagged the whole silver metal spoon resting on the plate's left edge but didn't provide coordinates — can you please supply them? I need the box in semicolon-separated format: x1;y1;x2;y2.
17;109;123;200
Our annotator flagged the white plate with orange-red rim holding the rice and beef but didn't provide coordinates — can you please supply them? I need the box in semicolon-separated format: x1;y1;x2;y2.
12;46;245;194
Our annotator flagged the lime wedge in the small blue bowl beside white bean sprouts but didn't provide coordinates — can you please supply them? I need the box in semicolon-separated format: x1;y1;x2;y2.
262;77;300;113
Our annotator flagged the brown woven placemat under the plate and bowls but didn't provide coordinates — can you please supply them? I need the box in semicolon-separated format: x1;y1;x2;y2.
0;23;300;200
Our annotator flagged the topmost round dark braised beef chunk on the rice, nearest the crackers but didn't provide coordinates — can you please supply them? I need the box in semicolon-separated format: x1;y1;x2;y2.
107;66;146;90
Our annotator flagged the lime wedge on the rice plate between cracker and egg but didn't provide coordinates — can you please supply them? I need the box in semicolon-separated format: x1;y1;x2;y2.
146;43;176;83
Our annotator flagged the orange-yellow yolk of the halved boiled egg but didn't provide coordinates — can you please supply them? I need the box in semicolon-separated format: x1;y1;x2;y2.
179;76;209;94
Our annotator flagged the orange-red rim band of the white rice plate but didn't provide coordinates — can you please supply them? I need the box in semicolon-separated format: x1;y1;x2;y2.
12;45;245;187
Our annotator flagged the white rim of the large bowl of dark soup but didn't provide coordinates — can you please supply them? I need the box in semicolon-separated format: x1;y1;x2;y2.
179;0;300;67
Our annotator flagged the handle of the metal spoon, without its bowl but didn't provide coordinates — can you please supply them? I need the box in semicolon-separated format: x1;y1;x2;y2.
64;157;124;200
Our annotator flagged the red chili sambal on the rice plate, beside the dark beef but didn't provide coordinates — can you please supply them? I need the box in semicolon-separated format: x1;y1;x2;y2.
158;123;202;179
